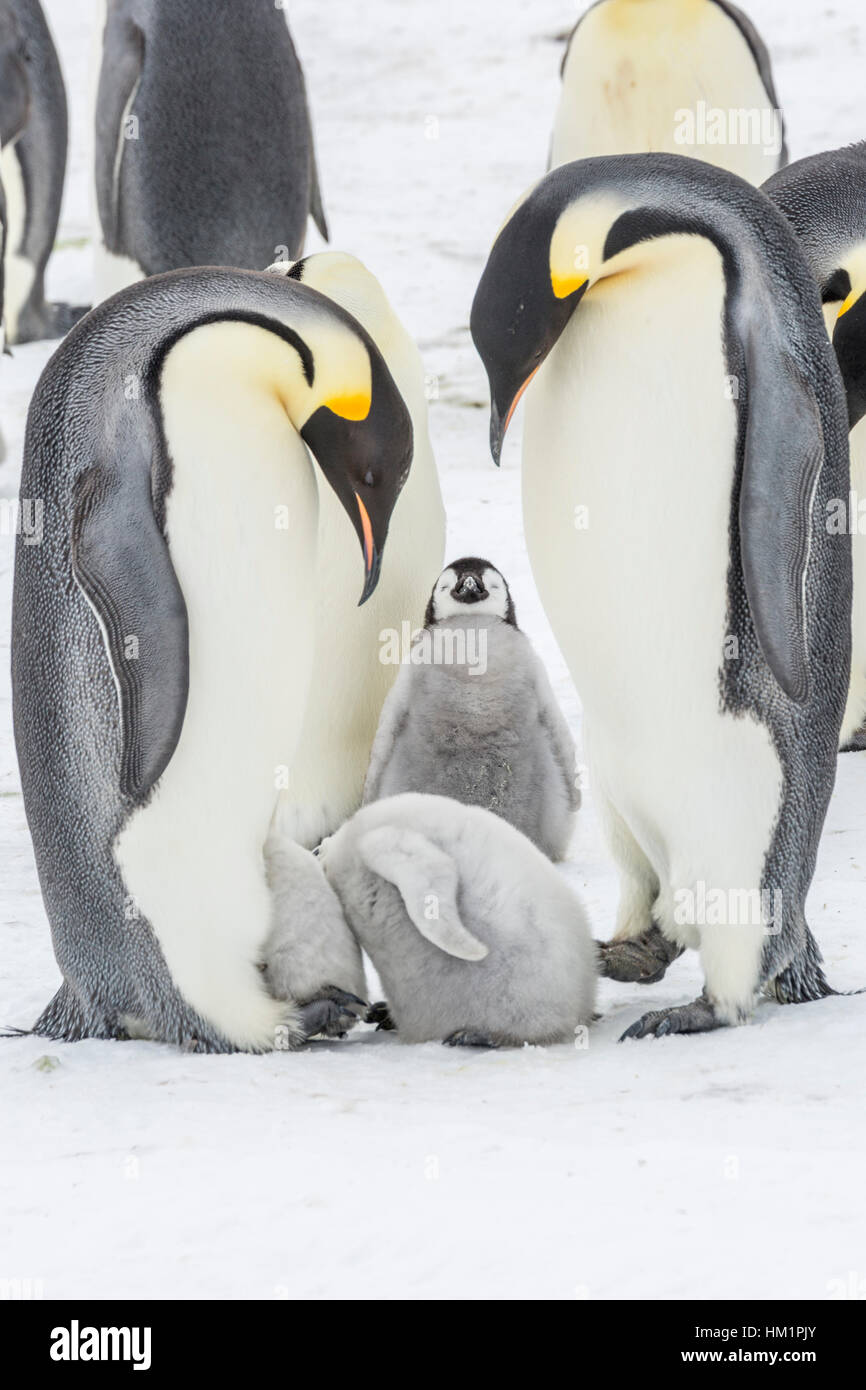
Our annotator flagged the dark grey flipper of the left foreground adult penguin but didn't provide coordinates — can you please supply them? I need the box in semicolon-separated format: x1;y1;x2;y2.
72;458;189;801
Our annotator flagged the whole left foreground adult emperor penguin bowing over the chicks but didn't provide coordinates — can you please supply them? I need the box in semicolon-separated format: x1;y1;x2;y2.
13;268;411;1051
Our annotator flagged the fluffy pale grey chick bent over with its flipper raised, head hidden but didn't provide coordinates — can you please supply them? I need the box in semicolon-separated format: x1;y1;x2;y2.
320;794;596;1047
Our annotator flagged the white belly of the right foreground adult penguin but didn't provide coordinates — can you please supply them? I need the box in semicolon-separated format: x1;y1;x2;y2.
523;238;781;1011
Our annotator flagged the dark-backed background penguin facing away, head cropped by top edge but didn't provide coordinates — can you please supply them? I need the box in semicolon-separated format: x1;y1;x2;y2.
95;0;328;297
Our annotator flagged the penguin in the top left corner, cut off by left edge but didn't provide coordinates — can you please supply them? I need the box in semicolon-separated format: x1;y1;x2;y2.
0;0;85;343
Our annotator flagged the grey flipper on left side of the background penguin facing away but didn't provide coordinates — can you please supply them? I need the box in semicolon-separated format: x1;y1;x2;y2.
95;3;145;256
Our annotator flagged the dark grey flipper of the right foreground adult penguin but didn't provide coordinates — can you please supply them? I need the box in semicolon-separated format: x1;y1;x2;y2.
740;318;824;705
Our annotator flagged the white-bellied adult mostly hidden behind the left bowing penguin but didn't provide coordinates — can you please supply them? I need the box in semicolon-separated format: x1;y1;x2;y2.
264;252;445;849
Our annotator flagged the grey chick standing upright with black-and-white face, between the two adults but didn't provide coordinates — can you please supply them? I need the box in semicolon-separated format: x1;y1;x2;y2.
364;557;580;859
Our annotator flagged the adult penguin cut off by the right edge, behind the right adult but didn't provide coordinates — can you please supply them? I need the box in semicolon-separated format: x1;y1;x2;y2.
763;140;866;749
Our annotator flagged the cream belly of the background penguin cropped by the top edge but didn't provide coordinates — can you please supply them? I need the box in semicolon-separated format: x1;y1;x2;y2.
550;0;787;183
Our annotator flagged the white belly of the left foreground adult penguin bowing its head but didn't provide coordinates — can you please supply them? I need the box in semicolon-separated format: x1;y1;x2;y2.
115;324;317;1047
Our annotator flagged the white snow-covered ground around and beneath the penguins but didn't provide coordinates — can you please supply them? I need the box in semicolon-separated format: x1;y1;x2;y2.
0;0;866;1300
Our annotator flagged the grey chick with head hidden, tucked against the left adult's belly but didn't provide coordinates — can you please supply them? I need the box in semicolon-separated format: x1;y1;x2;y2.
261;835;367;1037
